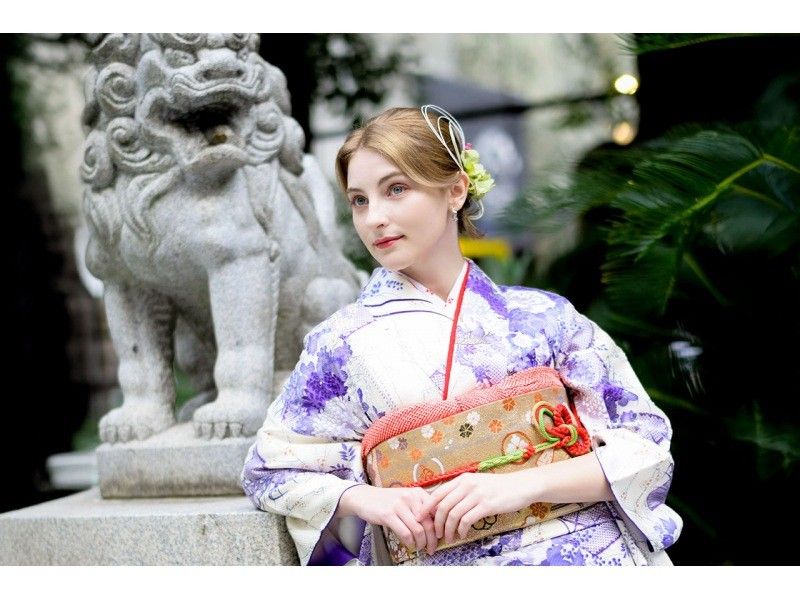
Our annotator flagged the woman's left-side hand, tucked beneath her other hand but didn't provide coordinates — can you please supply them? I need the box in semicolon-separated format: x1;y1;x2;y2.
339;484;438;554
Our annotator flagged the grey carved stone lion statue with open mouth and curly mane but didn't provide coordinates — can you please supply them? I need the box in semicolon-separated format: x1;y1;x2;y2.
81;34;366;443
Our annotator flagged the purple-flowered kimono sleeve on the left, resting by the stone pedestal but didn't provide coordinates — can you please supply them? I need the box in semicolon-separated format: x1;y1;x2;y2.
241;329;374;565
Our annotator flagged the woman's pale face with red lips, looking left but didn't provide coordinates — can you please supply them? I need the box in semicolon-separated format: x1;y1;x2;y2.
347;148;466;271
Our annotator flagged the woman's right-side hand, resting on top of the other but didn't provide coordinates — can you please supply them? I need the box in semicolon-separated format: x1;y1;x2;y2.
423;472;535;544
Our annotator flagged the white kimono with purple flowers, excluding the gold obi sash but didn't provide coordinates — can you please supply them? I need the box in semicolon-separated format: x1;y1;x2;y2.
242;260;683;565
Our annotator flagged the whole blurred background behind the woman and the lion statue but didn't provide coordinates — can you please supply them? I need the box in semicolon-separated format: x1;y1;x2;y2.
0;33;800;565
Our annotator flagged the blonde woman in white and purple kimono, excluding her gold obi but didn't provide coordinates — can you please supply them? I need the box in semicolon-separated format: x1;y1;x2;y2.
242;106;683;565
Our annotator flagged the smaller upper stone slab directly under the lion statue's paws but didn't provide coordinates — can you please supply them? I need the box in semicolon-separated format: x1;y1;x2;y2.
97;423;255;498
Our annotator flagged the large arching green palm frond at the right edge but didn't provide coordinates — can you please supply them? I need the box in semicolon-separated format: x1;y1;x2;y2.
603;130;800;314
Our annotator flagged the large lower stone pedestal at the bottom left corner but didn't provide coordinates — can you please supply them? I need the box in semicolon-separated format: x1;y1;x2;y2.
0;487;299;565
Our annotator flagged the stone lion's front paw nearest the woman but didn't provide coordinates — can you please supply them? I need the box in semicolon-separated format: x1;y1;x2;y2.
192;391;267;440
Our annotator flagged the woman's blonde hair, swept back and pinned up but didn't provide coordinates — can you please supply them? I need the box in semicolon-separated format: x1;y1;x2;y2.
336;108;485;239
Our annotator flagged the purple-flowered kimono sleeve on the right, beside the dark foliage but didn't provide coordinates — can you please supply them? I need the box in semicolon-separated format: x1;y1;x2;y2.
555;300;683;552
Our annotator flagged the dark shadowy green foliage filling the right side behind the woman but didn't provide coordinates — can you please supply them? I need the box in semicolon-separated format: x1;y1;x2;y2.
496;34;800;564
